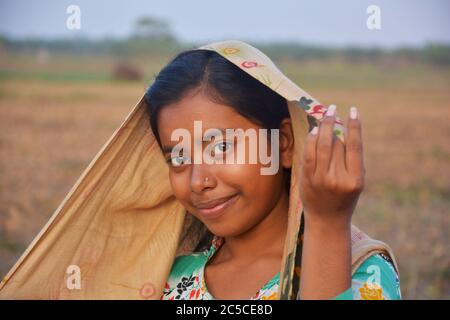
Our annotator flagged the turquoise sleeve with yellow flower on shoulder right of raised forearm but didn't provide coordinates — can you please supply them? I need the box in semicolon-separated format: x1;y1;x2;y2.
334;254;401;300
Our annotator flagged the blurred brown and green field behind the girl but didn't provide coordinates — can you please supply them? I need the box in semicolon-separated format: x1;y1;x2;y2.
0;54;450;299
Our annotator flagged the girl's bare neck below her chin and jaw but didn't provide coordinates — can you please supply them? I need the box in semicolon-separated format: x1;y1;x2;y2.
221;192;289;260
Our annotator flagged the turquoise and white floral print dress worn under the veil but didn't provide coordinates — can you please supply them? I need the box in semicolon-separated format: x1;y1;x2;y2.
160;236;401;300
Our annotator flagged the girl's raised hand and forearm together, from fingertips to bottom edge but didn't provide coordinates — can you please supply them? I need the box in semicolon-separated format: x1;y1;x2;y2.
300;106;365;299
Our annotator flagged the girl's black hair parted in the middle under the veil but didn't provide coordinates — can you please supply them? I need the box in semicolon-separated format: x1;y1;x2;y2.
145;49;290;250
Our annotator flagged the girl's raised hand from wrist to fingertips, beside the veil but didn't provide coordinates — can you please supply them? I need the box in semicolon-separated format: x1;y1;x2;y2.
300;105;365;223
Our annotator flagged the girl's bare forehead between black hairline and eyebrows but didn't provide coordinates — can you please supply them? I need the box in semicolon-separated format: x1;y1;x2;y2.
157;94;260;141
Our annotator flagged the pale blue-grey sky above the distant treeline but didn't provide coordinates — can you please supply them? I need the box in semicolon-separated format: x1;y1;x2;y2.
0;0;450;47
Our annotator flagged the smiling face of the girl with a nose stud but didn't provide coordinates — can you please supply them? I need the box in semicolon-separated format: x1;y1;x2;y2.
158;93;293;237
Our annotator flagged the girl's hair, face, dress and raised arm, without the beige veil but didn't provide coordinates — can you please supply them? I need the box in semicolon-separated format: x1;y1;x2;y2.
146;45;400;300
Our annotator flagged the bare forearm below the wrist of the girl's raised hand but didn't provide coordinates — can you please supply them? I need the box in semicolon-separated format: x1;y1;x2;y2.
300;215;351;299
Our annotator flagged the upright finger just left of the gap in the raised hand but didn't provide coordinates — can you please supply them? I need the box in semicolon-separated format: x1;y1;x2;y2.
315;105;336;175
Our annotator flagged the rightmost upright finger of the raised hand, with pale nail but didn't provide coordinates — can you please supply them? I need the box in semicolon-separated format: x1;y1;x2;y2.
345;107;364;178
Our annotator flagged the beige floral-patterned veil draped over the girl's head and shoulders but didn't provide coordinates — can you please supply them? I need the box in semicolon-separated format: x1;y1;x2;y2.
0;40;398;299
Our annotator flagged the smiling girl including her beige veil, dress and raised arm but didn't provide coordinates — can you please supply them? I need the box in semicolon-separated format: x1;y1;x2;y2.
0;41;400;299
